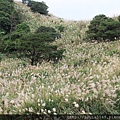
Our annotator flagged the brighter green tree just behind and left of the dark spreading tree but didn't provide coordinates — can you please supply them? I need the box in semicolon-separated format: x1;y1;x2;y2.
2;22;30;53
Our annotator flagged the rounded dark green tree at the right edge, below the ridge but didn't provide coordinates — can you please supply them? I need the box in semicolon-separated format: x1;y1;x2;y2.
86;15;120;41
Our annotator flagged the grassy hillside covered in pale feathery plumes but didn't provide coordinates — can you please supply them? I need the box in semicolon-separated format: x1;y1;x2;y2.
0;2;120;114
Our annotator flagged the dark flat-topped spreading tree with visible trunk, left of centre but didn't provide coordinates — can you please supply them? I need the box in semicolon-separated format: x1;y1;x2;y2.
17;33;63;65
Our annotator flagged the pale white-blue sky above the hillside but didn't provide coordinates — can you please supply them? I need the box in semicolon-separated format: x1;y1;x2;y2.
18;0;120;20
